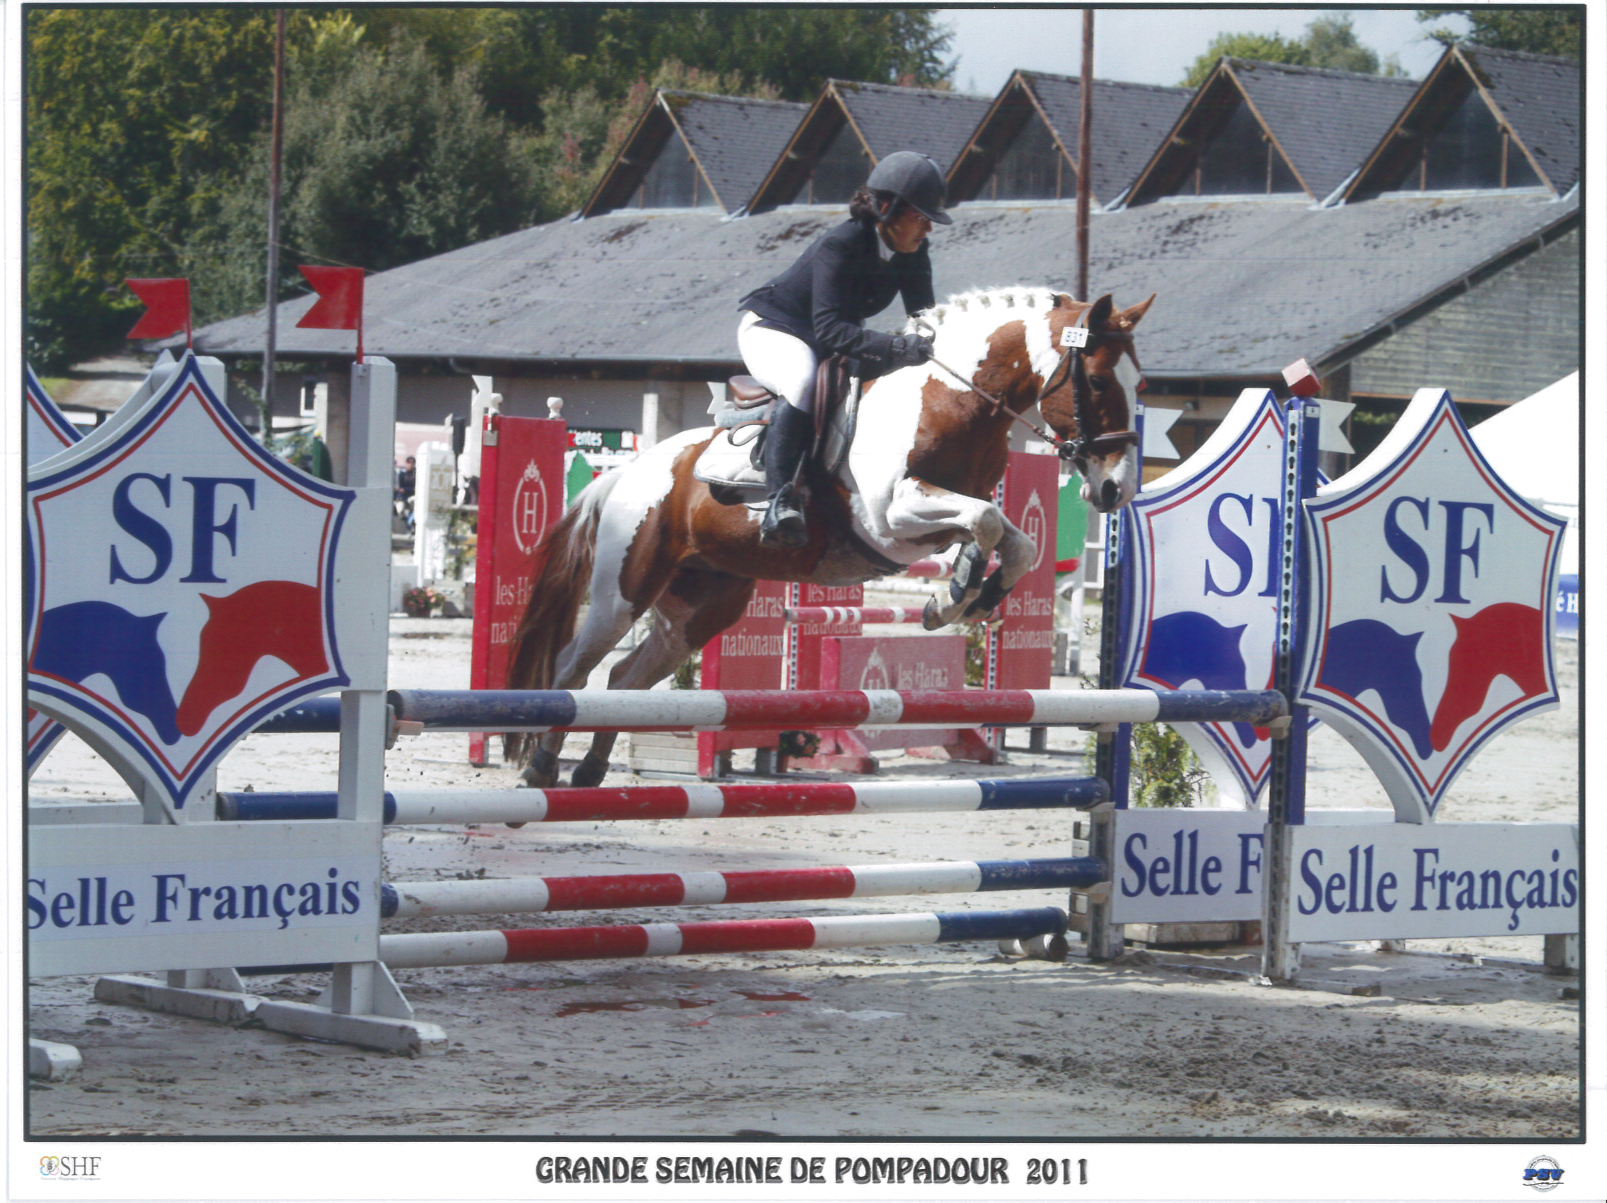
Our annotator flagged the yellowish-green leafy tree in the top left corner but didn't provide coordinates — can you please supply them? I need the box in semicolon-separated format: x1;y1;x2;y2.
24;8;292;369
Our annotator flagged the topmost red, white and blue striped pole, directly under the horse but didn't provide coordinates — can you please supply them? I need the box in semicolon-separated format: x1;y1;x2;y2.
389;689;1287;732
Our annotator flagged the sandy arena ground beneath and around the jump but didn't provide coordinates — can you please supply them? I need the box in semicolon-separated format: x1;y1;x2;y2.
27;618;1581;1156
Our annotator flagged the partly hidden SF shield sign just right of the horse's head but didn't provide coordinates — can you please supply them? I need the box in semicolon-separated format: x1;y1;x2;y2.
1123;389;1284;805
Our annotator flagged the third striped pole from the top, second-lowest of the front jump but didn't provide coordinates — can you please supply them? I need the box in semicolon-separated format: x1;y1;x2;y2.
379;856;1107;919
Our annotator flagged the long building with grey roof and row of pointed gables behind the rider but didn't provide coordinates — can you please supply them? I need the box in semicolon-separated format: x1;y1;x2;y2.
194;47;1581;475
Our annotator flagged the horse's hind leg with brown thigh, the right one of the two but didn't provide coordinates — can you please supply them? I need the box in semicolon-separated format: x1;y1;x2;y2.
570;569;754;785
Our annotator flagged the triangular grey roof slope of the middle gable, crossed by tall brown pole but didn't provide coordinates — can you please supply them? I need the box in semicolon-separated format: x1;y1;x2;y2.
1020;71;1192;204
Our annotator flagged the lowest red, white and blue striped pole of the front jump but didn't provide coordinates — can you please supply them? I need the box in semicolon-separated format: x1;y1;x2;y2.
379;906;1067;969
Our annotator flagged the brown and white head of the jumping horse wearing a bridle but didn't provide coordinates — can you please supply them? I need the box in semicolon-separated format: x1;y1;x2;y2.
1038;294;1155;512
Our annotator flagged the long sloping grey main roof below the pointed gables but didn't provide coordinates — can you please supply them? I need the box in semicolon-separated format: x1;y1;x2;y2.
194;193;1580;379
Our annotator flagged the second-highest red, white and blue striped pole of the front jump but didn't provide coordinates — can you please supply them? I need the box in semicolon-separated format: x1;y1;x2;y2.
217;777;1110;824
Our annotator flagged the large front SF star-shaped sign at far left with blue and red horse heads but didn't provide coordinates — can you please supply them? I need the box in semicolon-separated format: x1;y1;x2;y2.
26;357;355;806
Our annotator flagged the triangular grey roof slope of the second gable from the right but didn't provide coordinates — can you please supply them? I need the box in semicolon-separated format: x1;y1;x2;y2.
1228;59;1417;201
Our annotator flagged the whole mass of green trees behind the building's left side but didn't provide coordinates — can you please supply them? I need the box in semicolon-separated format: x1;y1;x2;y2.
24;3;953;371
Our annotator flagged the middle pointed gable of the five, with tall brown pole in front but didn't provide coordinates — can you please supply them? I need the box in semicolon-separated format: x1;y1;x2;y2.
948;71;1191;204
